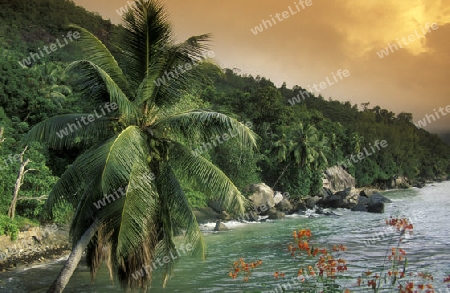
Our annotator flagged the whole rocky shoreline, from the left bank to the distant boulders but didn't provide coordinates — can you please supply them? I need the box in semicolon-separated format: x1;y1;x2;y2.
0;167;446;273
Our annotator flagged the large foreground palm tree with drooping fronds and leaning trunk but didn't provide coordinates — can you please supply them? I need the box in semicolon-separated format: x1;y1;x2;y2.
25;0;256;292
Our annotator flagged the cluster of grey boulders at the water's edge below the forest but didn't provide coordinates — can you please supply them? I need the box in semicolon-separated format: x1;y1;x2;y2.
195;166;398;231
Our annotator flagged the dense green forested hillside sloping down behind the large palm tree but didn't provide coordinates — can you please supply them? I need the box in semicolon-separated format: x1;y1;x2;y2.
0;0;450;233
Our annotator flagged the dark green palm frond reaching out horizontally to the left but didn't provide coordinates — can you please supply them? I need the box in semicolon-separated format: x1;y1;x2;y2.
22;114;114;149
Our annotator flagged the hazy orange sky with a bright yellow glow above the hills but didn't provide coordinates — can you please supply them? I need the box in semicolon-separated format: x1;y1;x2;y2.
74;0;450;133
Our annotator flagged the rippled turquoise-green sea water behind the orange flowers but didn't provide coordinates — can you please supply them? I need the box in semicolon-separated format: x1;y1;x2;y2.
0;182;450;293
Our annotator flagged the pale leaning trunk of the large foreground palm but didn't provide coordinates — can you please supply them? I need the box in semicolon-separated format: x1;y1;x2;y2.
47;220;100;293
